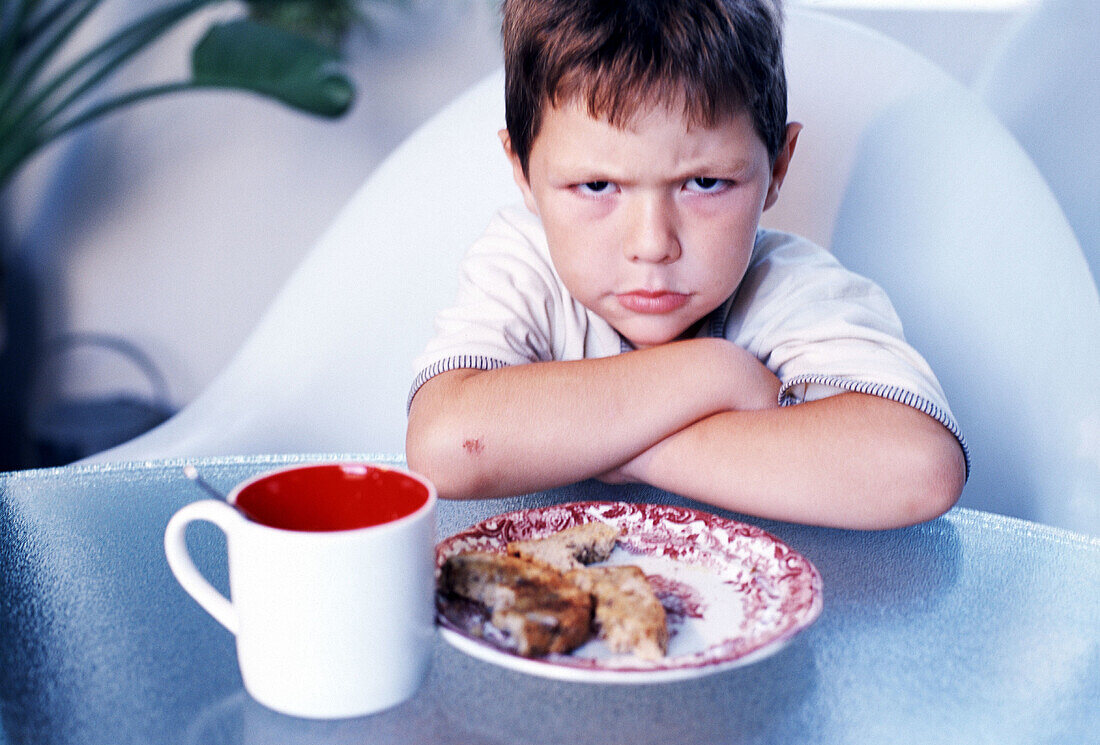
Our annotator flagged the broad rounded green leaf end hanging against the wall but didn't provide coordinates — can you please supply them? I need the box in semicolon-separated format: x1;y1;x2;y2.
191;20;355;117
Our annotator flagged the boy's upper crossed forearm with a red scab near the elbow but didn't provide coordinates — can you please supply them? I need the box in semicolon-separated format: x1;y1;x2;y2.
406;339;779;497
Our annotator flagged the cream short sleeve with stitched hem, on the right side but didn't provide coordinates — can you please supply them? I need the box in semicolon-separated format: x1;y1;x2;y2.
726;231;969;470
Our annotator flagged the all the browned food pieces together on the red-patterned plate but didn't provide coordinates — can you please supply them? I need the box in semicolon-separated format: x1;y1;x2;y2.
439;523;669;660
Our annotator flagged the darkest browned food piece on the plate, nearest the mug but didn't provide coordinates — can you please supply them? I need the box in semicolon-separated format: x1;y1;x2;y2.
439;551;593;657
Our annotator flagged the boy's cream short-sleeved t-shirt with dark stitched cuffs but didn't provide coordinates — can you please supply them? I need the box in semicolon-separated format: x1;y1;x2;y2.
409;207;969;472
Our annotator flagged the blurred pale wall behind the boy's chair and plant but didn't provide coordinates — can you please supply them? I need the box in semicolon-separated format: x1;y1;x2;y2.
0;0;1030;464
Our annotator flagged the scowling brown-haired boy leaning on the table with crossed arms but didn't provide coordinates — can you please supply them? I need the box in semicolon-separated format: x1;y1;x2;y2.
407;0;967;528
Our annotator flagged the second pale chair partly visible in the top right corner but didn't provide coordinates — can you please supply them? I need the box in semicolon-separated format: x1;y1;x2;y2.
975;0;1100;282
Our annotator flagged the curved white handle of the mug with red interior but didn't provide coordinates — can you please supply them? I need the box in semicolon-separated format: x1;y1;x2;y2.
164;500;244;635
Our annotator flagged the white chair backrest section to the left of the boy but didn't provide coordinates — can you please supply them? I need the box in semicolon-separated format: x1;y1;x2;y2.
89;66;520;460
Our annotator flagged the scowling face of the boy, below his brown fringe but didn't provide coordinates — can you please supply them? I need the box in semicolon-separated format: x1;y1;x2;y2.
501;97;800;349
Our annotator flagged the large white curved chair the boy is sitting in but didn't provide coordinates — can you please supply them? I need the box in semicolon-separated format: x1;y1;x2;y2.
94;11;1100;533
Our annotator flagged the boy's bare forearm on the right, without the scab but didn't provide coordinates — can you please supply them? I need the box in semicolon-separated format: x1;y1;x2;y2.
628;394;965;529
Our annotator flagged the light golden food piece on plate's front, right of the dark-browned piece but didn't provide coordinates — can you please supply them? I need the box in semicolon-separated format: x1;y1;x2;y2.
565;566;669;659
